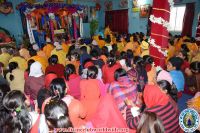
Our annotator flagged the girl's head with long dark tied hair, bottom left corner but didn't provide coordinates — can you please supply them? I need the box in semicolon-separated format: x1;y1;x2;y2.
3;90;31;133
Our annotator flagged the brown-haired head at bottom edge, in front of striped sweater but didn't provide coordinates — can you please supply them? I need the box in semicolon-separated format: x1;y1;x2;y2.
137;111;165;133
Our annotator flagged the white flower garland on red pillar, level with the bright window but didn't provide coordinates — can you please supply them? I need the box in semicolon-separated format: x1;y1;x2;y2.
149;15;170;31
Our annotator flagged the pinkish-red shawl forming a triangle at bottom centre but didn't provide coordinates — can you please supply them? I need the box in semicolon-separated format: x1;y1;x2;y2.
91;94;135;133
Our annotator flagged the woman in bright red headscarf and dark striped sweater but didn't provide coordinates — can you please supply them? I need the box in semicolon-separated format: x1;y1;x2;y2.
126;85;181;133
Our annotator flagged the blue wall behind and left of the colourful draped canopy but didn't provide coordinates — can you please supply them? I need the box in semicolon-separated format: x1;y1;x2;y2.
0;0;98;44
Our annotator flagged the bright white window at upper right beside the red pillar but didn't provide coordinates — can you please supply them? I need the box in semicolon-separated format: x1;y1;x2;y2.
169;5;185;32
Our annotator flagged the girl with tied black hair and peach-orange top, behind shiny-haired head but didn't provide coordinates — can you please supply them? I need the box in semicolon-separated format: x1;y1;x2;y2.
42;78;86;128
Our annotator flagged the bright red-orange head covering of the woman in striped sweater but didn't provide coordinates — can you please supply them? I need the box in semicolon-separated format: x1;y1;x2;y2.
143;85;169;108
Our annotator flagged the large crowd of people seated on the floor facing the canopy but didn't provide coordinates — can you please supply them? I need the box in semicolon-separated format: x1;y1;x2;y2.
0;33;200;133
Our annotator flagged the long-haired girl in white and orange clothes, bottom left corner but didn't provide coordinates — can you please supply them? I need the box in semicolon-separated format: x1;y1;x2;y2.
3;90;48;133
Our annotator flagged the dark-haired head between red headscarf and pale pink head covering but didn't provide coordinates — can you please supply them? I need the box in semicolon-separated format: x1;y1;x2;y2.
157;80;178;102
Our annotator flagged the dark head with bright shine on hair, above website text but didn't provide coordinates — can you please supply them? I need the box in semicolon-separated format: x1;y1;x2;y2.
44;100;73;130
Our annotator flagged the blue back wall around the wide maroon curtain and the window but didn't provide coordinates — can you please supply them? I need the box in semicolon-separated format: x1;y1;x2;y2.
99;0;200;36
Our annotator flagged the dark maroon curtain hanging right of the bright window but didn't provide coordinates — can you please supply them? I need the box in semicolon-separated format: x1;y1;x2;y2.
181;3;195;36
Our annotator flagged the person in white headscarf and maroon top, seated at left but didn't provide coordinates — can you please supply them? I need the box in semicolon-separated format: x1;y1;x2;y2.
24;61;45;110
